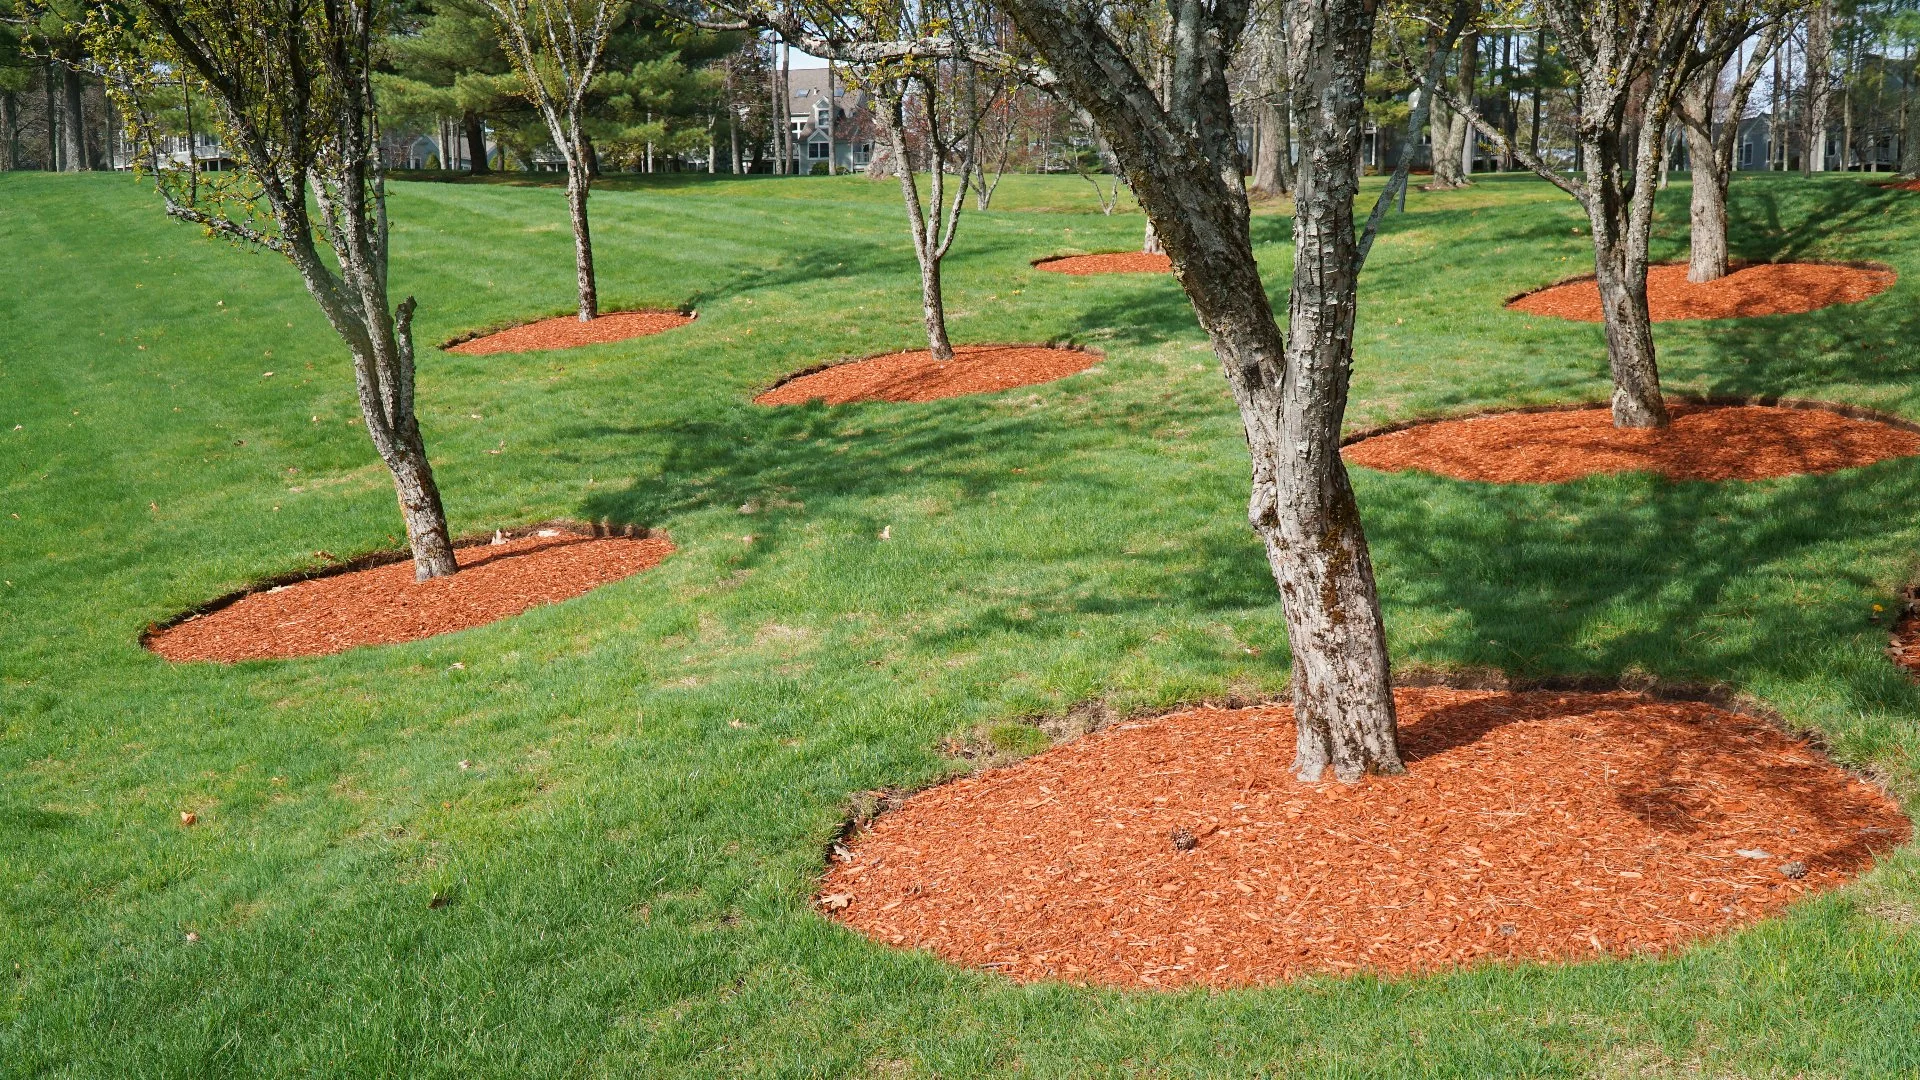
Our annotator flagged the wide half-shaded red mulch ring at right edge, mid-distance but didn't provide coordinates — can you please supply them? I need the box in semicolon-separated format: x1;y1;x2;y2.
1342;402;1920;484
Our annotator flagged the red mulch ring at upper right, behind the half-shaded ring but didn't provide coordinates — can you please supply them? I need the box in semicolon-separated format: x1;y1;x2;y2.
1507;263;1899;323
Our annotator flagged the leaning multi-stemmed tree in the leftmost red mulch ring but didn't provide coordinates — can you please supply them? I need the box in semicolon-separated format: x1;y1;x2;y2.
94;0;457;580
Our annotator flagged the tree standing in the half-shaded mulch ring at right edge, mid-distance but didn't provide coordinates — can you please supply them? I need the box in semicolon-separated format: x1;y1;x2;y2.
1428;0;1745;427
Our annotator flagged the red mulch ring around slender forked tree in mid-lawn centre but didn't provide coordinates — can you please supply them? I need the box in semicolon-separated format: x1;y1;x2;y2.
753;346;1100;405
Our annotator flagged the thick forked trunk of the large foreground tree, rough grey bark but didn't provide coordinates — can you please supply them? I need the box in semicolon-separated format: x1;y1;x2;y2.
1000;0;1404;782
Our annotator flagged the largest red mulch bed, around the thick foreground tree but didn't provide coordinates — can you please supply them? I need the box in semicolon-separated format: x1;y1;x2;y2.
822;690;1910;988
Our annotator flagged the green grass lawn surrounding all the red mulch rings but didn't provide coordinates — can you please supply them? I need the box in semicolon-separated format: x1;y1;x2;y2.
0;173;1920;1078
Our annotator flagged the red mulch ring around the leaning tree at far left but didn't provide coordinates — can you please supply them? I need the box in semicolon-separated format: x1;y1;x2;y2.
142;523;674;663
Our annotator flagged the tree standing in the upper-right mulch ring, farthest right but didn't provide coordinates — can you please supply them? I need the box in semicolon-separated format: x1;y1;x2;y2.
1674;8;1786;282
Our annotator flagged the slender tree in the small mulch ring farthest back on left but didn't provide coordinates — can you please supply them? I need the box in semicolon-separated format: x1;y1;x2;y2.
480;0;626;323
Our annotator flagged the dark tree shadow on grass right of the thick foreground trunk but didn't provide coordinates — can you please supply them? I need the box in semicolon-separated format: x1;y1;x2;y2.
1356;461;1920;707
